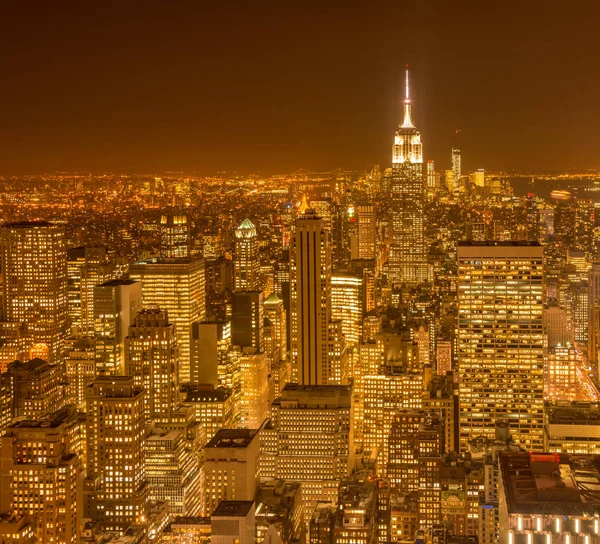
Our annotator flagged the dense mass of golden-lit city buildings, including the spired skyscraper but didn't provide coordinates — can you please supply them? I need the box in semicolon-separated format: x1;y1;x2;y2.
0;75;600;544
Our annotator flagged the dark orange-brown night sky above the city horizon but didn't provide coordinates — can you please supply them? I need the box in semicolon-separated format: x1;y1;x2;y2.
0;0;600;174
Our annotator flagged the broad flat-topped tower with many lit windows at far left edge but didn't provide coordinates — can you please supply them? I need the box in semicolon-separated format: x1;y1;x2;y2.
0;221;68;363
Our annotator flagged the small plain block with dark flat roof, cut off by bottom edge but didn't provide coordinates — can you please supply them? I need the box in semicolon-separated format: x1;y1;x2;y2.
210;500;255;544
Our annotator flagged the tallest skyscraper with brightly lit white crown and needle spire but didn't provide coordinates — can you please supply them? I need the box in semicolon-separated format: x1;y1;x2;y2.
389;70;427;283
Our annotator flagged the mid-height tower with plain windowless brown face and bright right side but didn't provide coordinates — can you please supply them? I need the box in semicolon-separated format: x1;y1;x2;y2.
190;321;231;386
